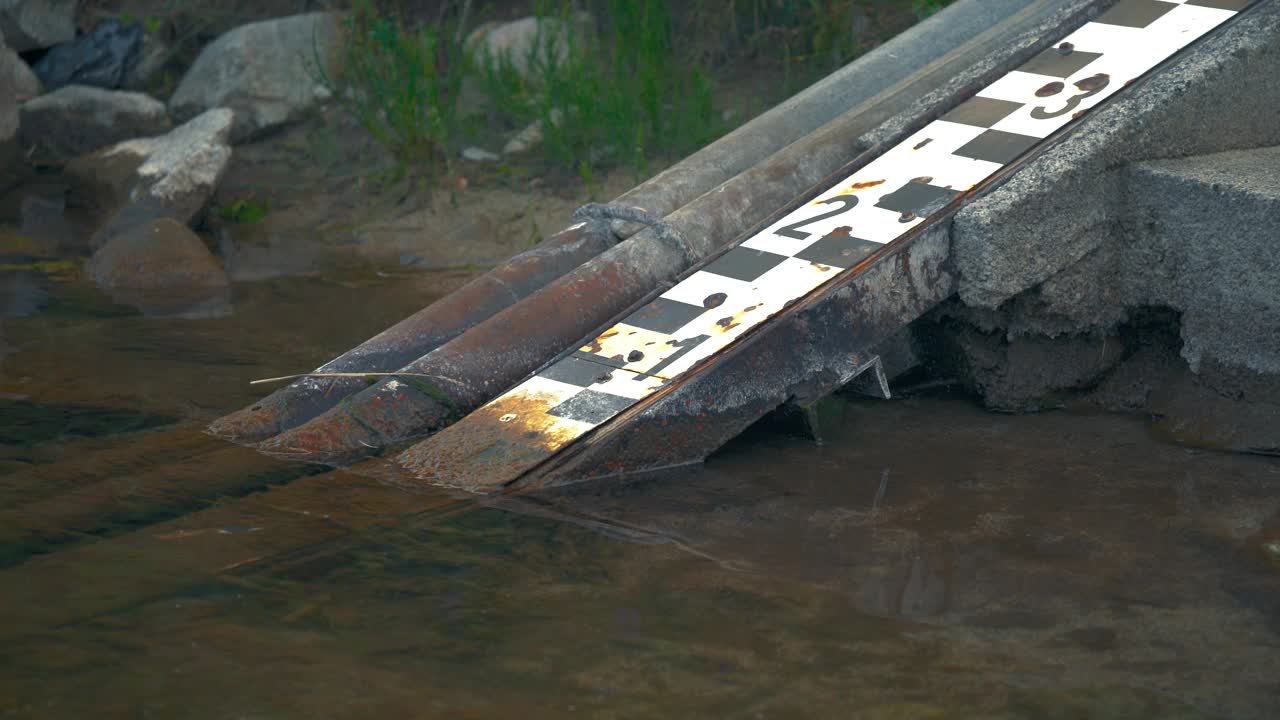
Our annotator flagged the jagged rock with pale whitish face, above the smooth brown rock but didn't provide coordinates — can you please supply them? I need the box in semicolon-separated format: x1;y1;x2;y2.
65;108;234;223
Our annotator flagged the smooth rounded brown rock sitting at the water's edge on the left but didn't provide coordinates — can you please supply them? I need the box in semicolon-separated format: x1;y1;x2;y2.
86;218;230;316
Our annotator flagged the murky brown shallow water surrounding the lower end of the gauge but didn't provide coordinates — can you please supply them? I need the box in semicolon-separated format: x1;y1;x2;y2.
0;243;1280;719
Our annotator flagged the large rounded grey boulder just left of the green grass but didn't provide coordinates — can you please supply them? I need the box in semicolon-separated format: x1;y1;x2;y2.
169;13;340;142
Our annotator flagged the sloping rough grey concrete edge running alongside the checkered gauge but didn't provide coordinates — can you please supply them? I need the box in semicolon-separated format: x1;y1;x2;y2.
952;3;1280;309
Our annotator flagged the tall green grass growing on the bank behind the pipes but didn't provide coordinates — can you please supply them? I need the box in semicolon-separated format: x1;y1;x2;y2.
325;0;950;187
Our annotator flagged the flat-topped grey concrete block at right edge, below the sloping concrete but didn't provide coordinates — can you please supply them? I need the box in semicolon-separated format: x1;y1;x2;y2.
1121;142;1280;373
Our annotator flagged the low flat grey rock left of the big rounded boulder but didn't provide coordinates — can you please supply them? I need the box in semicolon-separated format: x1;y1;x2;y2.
22;85;170;158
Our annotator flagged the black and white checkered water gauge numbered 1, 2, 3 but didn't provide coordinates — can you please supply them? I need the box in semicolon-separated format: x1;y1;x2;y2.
468;0;1252;450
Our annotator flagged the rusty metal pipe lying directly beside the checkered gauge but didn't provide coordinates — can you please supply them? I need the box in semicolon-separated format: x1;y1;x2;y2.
252;0;1090;462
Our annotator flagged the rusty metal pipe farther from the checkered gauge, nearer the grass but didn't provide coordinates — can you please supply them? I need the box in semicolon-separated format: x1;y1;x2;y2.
209;0;1044;442
